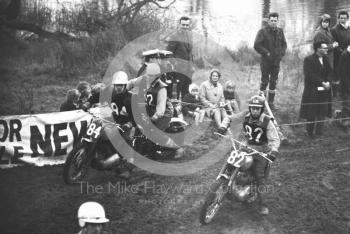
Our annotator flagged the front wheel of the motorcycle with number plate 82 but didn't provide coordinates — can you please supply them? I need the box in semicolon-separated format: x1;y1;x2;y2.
199;178;228;225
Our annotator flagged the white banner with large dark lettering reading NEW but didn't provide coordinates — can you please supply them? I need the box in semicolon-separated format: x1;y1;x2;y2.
0;110;92;164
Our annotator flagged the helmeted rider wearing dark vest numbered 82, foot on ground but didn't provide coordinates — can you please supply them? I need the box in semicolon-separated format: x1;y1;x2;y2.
243;95;280;215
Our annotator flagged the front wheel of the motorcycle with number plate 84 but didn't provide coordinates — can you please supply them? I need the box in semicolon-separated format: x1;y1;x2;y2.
63;144;89;184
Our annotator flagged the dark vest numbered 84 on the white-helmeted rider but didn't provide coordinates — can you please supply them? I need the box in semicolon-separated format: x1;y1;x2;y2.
110;92;136;126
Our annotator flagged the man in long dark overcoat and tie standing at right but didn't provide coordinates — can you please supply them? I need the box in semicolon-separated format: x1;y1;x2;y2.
300;41;332;136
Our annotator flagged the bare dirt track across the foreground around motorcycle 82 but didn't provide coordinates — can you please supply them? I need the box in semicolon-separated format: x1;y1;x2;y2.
0;121;350;234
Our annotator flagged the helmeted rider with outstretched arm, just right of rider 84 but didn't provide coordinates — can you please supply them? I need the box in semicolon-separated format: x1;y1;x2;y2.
127;63;184;158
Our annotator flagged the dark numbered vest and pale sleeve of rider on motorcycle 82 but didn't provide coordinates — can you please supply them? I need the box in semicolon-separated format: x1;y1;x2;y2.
243;113;280;151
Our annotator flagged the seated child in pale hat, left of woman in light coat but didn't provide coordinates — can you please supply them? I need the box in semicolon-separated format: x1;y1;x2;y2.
182;84;205;125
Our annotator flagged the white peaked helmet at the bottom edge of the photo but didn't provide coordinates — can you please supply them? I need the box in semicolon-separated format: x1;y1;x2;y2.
78;202;109;227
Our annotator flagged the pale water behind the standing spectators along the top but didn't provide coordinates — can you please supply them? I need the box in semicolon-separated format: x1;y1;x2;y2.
25;0;350;49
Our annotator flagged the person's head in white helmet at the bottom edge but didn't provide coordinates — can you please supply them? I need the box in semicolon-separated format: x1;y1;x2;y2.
78;202;109;234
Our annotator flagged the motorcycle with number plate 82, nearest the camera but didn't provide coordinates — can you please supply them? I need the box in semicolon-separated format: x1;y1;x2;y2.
199;134;267;225
